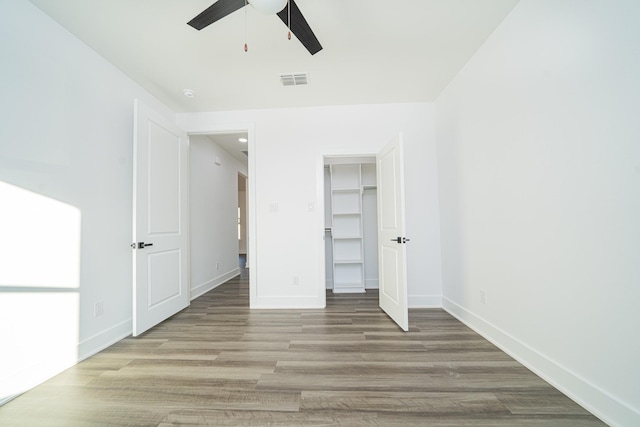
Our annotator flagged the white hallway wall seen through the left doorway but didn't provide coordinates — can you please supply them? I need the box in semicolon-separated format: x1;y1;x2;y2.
189;135;247;299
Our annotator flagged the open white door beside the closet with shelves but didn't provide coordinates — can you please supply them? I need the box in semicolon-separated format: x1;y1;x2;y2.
376;134;409;331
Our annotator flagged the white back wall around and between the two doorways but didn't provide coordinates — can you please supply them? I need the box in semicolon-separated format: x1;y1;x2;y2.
178;103;441;307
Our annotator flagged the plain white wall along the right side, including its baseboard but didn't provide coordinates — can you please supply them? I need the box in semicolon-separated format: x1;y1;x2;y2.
436;0;640;426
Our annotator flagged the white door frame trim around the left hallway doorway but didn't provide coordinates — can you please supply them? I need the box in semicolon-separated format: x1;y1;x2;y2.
184;123;258;308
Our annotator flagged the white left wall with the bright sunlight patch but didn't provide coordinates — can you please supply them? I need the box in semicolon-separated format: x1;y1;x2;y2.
0;0;169;402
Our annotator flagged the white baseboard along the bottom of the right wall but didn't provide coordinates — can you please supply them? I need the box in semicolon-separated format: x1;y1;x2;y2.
442;297;640;427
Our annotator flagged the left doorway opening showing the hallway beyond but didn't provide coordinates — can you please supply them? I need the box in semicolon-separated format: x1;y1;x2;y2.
189;131;250;299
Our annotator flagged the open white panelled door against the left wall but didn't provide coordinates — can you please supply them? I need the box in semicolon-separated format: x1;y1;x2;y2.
132;100;189;336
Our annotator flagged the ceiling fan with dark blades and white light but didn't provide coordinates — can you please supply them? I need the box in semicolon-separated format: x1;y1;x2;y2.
187;0;322;55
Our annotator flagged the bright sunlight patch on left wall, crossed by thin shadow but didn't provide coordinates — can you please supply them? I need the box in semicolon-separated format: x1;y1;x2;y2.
0;181;81;403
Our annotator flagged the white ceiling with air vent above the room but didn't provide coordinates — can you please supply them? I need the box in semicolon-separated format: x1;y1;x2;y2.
30;0;517;112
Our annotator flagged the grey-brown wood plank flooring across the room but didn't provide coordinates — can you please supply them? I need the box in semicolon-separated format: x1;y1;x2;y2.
0;275;604;427
